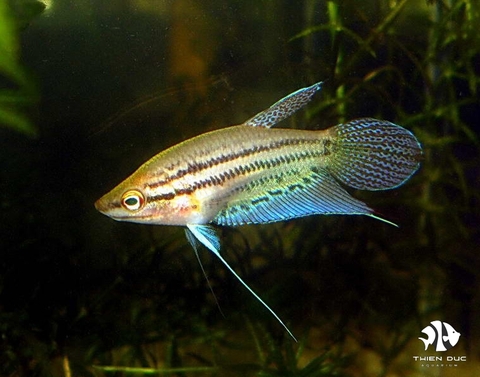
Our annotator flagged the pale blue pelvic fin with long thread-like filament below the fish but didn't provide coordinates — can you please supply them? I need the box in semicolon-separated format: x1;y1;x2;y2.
187;224;297;341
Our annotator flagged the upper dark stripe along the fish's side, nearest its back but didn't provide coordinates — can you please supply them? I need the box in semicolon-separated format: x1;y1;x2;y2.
147;138;330;188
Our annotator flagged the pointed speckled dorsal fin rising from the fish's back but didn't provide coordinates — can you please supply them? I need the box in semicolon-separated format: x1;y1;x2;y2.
244;82;322;128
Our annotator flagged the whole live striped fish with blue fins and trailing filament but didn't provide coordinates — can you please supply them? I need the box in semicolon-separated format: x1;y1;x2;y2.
95;82;422;340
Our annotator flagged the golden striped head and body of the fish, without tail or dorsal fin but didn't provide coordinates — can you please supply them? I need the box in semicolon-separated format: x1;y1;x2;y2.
97;125;335;225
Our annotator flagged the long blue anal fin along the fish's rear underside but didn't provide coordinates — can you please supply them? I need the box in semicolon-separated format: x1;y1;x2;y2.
213;169;395;226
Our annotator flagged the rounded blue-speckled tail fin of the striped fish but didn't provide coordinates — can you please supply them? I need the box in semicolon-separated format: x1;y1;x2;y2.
328;118;422;190
